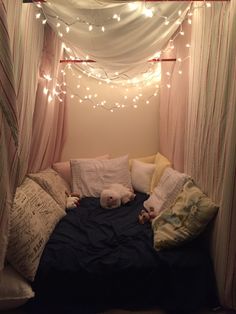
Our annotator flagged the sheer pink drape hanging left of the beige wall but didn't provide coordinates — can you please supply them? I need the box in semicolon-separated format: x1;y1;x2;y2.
28;26;66;172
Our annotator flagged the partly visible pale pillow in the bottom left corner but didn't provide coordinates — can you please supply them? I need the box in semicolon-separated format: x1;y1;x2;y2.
0;265;34;311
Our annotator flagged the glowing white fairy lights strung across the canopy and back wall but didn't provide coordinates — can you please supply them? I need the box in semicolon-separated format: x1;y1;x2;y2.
32;2;211;112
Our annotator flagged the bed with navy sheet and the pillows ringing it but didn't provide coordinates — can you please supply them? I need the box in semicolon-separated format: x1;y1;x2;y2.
7;154;217;314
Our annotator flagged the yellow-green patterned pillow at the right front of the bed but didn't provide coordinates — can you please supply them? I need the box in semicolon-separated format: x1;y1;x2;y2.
152;180;218;250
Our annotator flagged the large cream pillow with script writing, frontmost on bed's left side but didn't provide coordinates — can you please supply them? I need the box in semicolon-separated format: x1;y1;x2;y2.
7;178;65;280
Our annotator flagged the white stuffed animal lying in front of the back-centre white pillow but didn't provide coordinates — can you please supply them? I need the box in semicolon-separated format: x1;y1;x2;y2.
100;183;135;208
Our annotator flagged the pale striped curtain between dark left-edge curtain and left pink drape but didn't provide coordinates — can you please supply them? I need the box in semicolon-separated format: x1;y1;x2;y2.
7;0;44;184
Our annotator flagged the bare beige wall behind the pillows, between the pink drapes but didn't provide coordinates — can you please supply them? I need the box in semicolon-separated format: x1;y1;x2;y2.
61;71;159;161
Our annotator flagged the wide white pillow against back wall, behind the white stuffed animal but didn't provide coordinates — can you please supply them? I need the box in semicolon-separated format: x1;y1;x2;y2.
70;155;132;197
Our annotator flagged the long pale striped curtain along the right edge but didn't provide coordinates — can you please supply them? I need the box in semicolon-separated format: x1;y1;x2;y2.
184;1;236;308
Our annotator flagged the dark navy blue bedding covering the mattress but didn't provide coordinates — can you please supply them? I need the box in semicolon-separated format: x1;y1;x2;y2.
30;193;218;313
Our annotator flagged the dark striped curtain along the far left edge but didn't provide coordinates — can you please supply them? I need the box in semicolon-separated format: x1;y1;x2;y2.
0;0;19;270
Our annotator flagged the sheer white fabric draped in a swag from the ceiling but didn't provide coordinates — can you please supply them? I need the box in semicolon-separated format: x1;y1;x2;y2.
42;0;189;82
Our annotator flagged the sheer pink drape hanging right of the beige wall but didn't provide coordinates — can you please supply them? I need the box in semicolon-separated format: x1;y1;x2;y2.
159;22;191;171
